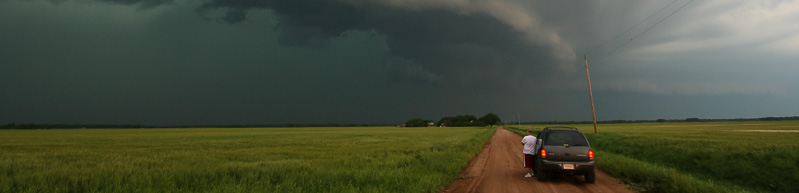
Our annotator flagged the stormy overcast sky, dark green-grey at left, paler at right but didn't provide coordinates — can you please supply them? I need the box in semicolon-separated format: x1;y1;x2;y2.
0;0;799;125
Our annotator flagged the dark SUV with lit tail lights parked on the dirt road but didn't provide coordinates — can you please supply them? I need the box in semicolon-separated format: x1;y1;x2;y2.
535;127;596;183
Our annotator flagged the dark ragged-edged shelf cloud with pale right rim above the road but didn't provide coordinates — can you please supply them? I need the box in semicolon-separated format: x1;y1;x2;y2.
188;0;563;87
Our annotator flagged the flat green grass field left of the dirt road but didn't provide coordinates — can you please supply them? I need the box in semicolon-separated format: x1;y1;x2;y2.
0;127;494;192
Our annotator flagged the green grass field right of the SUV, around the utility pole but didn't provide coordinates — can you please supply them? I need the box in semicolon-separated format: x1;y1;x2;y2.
506;121;799;192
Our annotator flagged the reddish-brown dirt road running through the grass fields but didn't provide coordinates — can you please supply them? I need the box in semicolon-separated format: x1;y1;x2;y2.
441;127;633;193
